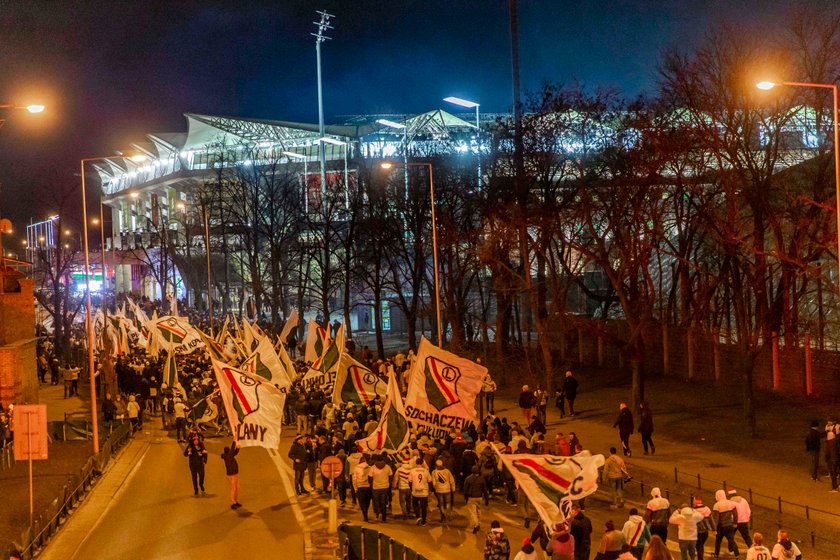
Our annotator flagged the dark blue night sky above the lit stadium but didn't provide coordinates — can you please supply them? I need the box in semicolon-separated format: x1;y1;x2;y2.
0;0;812;237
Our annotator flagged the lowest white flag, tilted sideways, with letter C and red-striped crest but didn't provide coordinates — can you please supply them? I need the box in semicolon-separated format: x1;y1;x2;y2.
491;446;604;527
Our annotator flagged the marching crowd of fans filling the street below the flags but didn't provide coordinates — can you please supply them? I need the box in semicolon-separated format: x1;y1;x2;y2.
19;302;812;560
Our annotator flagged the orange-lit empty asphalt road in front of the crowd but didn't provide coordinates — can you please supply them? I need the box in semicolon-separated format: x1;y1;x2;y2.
41;426;304;560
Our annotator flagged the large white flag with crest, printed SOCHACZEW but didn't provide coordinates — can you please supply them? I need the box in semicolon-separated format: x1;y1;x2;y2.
405;337;487;438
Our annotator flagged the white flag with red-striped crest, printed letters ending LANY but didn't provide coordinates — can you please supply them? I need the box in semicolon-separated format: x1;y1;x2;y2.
213;360;286;449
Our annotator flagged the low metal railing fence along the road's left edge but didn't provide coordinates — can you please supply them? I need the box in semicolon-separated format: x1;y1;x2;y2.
13;424;132;560
